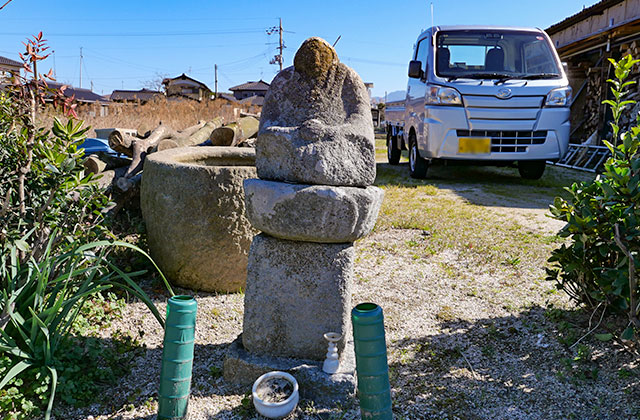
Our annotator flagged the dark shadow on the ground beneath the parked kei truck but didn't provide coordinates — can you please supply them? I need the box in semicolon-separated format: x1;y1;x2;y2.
375;163;593;209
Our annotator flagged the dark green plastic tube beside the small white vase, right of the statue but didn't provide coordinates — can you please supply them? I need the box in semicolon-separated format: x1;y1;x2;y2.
351;303;393;420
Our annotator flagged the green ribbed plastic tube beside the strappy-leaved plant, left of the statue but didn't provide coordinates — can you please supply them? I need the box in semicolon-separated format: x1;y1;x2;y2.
158;296;198;419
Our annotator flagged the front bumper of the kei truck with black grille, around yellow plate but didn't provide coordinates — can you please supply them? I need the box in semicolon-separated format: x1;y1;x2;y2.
418;106;570;161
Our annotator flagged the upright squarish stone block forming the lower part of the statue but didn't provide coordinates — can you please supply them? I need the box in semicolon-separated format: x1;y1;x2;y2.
242;234;354;360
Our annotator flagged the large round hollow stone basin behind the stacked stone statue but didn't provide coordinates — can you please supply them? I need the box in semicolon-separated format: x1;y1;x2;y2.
140;147;256;292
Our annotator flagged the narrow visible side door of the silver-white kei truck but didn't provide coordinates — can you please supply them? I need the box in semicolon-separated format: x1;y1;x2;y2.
405;37;431;150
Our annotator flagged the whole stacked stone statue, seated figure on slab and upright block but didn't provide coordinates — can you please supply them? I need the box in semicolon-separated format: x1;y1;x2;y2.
242;38;383;360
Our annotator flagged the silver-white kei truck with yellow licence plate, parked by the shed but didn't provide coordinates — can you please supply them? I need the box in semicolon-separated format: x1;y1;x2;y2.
385;26;571;179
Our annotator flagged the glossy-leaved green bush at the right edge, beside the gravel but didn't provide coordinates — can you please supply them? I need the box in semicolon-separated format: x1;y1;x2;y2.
547;56;640;339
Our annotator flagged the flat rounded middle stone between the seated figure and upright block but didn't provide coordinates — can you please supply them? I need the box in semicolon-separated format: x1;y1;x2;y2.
244;179;384;243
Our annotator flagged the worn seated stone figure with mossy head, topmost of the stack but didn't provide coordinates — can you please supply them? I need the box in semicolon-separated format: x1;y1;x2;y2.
256;38;376;187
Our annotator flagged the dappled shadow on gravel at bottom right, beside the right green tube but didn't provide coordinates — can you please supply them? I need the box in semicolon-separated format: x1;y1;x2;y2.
389;307;640;420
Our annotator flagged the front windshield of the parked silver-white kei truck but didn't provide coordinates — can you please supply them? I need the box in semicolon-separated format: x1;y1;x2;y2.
436;30;561;79
